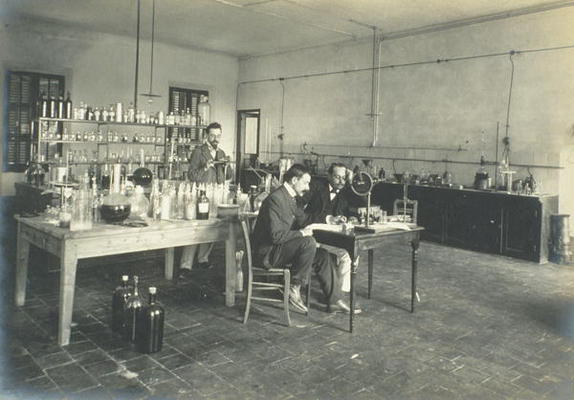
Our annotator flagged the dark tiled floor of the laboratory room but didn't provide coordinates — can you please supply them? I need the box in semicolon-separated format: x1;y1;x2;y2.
0;239;574;400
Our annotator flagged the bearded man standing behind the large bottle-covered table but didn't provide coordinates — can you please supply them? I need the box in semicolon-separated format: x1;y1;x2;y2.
179;122;229;277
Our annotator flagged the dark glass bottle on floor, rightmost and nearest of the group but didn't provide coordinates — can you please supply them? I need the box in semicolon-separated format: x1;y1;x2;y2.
136;287;165;354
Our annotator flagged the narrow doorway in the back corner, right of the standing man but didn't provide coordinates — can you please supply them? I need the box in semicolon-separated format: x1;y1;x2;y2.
235;109;261;190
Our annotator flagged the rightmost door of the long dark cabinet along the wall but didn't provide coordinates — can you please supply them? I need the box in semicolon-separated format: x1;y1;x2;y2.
502;198;541;261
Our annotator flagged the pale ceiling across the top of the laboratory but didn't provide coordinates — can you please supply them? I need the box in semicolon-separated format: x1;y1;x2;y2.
0;0;574;56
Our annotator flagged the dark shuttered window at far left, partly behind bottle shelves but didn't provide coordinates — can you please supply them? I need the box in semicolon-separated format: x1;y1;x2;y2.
3;71;64;172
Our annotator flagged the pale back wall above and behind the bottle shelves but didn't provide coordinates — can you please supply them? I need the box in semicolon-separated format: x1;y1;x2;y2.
0;17;238;196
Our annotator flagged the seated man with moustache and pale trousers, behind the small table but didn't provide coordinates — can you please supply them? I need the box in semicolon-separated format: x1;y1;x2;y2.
304;163;361;313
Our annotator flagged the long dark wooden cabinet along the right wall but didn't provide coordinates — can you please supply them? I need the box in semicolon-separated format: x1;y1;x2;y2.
373;183;558;263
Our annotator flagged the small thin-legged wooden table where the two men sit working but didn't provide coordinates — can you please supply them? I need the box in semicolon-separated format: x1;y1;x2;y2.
313;227;424;332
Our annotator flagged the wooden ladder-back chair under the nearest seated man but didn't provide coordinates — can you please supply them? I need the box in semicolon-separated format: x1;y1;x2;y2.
239;216;311;326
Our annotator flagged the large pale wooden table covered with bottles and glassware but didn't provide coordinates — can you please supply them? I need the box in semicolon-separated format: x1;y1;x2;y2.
16;216;236;346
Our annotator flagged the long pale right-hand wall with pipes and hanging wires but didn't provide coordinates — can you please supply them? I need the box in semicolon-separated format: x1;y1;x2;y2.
238;7;574;202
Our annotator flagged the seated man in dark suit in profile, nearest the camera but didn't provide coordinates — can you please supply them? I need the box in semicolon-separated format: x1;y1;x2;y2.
252;164;349;312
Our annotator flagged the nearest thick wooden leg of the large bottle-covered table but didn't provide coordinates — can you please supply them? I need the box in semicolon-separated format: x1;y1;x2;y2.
58;243;78;346
